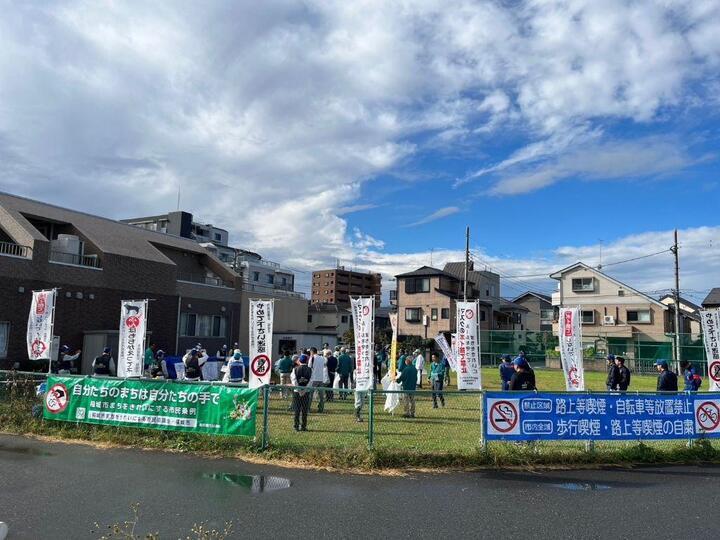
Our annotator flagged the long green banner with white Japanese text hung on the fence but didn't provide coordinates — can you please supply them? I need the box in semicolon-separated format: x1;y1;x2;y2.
43;376;258;437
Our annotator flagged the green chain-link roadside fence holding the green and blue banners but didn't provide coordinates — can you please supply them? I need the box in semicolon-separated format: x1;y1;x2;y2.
5;372;720;463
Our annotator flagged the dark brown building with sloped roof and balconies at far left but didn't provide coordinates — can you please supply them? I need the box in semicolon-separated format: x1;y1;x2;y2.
0;193;247;373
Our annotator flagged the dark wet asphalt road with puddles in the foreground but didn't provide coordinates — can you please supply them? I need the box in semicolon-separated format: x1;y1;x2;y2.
0;436;720;540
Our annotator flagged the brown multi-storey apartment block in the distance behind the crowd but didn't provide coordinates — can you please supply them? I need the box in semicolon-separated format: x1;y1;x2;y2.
312;266;382;307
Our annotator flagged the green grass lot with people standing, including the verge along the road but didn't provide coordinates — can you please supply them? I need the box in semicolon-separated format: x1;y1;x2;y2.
5;368;720;470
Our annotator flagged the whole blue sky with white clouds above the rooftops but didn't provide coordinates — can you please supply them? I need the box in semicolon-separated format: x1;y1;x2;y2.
0;0;720;302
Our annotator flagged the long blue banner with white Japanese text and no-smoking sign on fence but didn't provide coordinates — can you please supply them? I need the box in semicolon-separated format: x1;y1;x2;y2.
483;392;720;441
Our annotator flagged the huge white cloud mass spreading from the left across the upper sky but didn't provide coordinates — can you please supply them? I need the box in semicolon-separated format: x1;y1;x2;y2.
0;0;720;294
